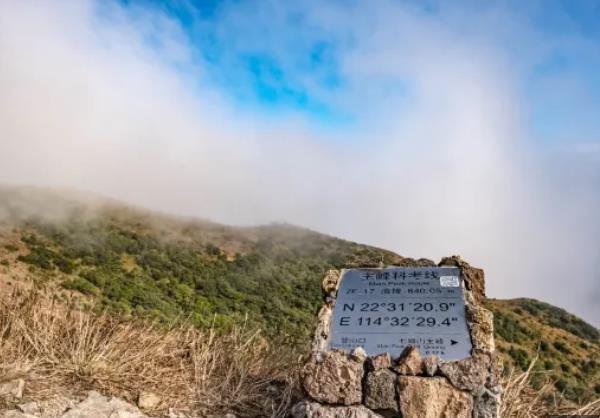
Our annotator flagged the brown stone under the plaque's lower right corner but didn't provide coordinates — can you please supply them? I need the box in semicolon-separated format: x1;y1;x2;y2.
439;354;490;391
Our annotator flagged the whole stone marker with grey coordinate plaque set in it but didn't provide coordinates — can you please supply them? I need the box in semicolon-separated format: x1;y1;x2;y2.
292;256;502;418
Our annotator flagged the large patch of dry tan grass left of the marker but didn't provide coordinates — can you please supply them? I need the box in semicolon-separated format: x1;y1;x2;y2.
0;290;299;417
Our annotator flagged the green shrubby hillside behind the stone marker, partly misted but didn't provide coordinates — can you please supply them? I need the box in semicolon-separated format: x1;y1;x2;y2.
0;189;600;401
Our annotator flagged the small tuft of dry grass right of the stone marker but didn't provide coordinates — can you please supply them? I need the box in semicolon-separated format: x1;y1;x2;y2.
500;358;600;418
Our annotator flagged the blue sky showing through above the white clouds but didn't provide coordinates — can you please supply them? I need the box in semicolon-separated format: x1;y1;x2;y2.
106;0;600;141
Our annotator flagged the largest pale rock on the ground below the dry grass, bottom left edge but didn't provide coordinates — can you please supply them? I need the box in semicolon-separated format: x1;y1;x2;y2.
62;391;148;418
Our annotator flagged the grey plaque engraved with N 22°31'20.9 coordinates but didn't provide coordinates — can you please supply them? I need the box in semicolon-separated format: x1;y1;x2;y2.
329;267;472;360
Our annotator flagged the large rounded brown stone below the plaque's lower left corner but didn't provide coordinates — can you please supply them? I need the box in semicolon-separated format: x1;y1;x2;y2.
302;351;364;405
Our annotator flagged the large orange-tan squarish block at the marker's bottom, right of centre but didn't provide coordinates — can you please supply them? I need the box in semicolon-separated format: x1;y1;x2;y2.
398;376;473;418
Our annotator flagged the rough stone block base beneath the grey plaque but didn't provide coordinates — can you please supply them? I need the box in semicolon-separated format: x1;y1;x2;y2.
294;348;501;418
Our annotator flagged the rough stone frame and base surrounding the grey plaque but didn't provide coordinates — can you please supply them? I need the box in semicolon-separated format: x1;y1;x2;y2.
292;256;502;418
